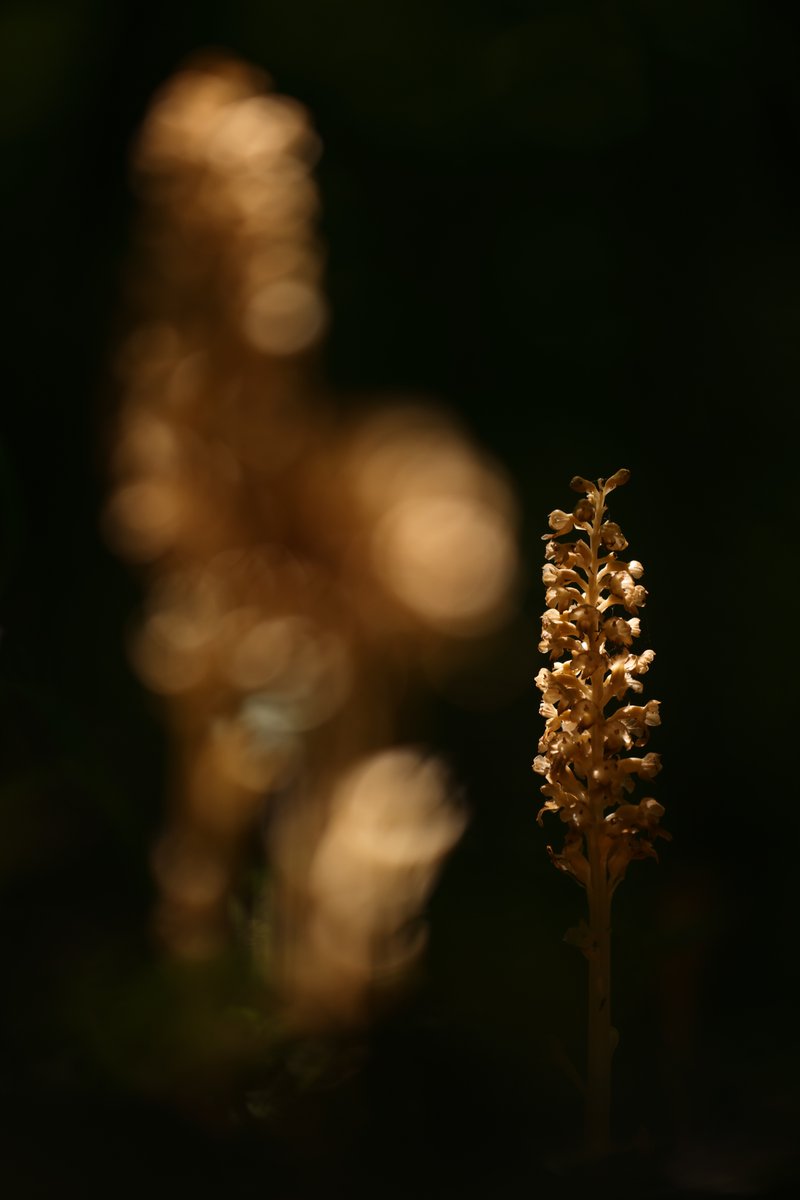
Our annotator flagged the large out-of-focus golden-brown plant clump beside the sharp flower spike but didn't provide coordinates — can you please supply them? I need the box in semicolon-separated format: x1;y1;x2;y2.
106;58;517;1028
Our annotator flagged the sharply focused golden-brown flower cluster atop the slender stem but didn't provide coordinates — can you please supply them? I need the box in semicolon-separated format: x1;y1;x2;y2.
534;469;669;892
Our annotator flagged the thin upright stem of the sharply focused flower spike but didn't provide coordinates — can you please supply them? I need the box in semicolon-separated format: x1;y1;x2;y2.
587;488;612;1156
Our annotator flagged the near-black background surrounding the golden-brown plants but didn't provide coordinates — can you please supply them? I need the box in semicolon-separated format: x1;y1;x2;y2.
0;0;800;1200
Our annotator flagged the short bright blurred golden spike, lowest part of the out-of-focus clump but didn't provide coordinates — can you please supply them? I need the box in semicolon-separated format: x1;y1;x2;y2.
275;750;464;1021
